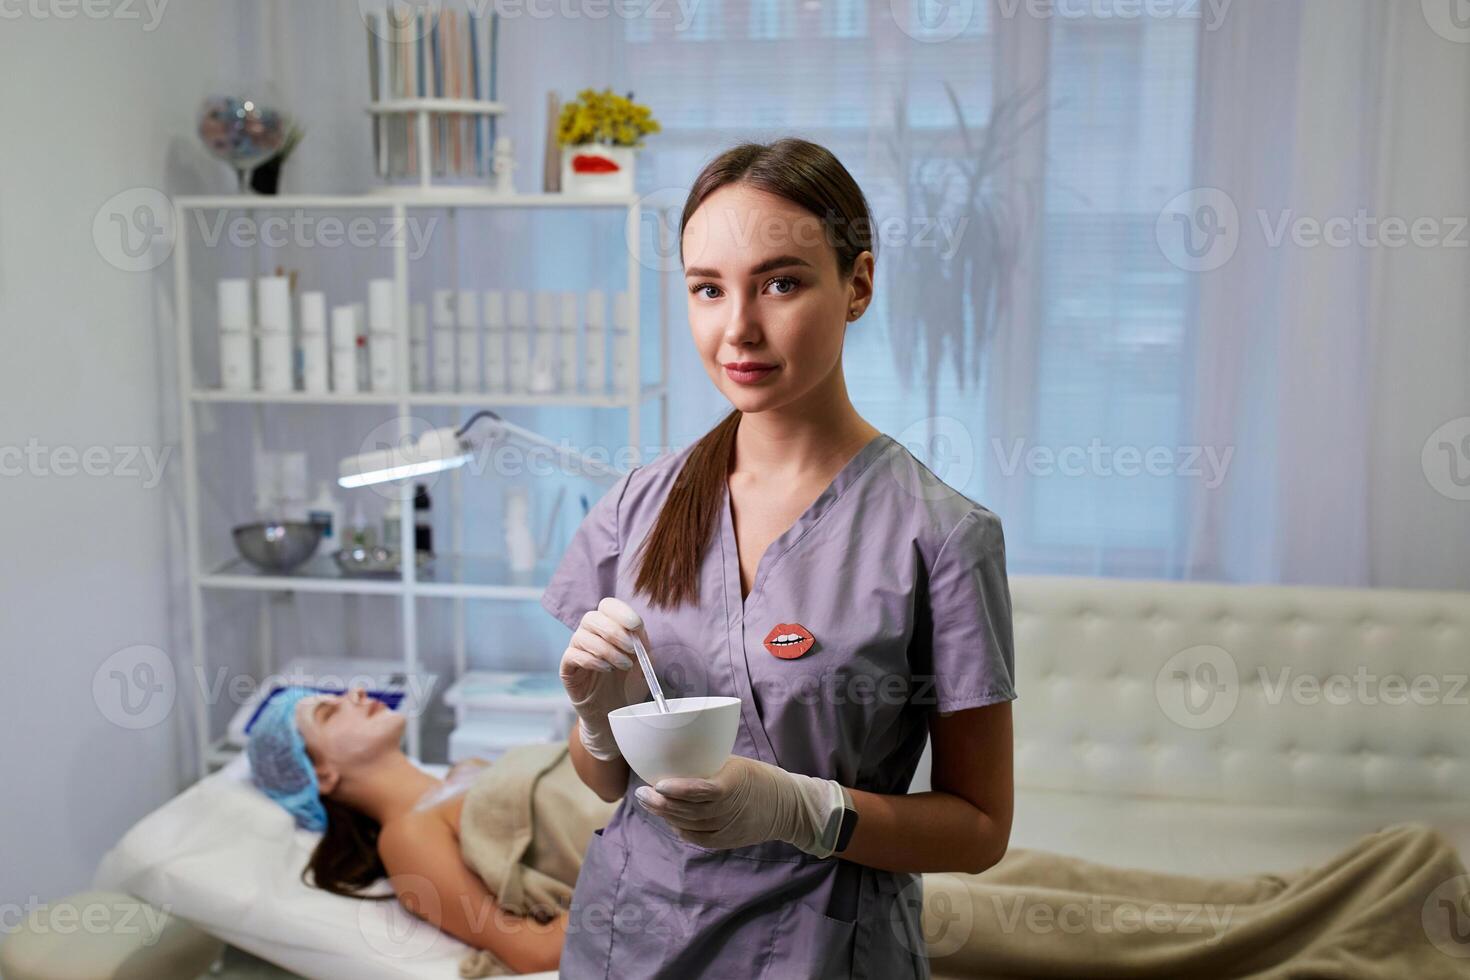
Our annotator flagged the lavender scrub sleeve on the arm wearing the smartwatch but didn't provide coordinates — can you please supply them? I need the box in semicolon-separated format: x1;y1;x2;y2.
929;507;1016;714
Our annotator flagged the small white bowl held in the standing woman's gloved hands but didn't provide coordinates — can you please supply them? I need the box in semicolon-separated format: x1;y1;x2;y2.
607;698;739;786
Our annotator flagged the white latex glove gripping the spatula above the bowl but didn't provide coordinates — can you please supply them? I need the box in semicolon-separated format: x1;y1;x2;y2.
560;595;653;763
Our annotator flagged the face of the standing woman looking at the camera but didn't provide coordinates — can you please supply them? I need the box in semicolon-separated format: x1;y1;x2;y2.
682;184;872;413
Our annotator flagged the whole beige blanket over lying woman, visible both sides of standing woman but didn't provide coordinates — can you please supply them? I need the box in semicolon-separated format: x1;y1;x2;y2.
460;743;1470;980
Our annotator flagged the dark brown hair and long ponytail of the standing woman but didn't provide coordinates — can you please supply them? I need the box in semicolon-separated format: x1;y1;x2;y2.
634;137;878;608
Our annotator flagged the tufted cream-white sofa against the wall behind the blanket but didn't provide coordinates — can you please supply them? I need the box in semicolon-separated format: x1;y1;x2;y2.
910;576;1470;874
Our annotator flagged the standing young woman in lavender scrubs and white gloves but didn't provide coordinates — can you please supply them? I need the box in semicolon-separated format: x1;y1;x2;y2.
541;140;1016;980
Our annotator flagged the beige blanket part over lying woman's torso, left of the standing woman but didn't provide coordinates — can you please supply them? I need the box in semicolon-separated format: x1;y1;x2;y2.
460;742;617;977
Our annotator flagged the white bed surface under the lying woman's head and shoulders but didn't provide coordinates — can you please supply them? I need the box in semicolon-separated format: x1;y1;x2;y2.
94;755;557;980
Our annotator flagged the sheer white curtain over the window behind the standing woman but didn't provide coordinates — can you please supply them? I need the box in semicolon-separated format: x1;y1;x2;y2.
622;0;1470;588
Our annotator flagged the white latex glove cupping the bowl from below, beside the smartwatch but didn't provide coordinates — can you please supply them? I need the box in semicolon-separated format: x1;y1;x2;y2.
635;755;842;858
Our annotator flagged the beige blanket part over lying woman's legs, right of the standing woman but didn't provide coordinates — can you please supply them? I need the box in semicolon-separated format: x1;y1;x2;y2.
923;823;1470;980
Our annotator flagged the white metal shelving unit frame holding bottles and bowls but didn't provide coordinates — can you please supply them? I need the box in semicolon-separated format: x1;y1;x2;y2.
173;190;669;777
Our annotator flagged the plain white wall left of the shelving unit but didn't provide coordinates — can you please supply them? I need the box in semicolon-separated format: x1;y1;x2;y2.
0;3;246;930
